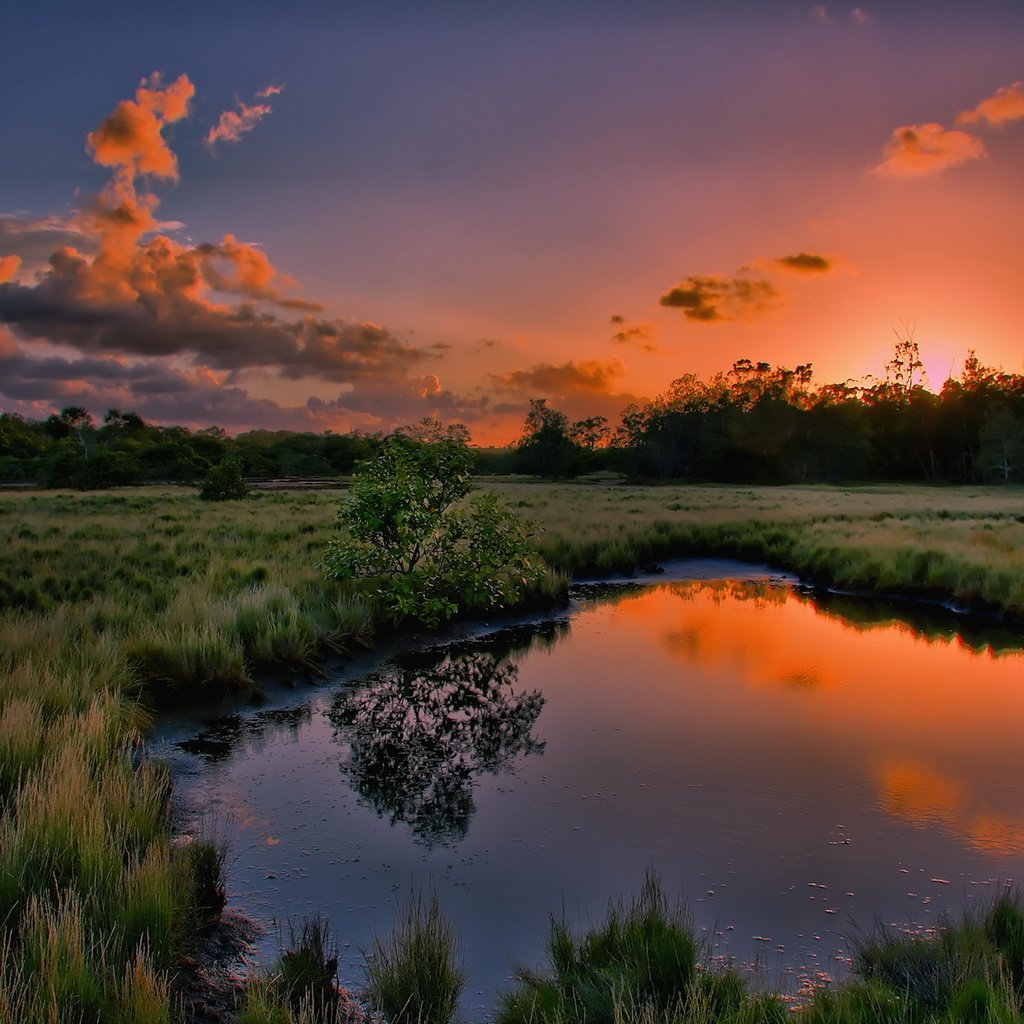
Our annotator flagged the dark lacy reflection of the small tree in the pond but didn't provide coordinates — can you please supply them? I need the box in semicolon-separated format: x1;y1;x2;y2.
331;644;544;845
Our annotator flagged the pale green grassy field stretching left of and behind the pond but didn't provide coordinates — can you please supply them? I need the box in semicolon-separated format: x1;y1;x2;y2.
0;481;1024;1024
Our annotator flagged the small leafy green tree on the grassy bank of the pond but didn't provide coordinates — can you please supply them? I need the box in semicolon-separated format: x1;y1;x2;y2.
321;431;544;626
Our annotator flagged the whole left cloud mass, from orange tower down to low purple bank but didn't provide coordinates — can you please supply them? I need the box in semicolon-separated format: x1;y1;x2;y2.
0;75;505;440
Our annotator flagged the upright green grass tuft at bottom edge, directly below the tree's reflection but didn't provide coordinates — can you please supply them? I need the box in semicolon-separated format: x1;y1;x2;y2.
364;892;466;1024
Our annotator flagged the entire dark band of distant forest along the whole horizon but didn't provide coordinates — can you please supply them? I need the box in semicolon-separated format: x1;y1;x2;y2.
6;341;1024;488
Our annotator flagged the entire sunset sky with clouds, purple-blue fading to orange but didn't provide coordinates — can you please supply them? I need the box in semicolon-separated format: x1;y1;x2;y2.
0;0;1024;443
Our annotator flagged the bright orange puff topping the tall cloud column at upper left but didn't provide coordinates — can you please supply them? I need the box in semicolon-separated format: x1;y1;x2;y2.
86;73;196;181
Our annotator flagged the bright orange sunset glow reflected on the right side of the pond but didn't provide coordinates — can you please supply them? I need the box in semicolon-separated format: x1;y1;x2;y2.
602;581;1024;855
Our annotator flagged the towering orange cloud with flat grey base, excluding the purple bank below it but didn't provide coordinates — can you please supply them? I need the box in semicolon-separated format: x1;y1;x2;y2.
0;76;425;383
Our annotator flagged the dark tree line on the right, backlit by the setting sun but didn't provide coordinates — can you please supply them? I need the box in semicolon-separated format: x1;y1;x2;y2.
516;340;1024;483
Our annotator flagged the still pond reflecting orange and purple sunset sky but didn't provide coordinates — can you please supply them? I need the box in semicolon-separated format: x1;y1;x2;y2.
156;563;1024;1020
